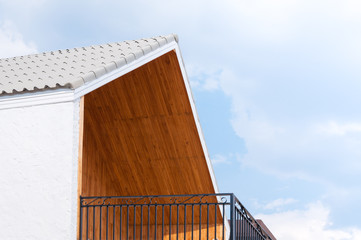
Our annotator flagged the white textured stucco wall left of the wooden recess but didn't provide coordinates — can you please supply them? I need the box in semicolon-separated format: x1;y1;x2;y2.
0;98;79;240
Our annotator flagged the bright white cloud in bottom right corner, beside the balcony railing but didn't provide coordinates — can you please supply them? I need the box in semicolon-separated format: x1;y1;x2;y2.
256;202;361;240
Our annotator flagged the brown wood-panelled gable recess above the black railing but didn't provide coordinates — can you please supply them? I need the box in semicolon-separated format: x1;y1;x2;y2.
81;52;214;196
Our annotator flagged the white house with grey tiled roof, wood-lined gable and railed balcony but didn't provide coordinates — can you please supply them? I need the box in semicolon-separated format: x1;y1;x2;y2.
0;35;271;240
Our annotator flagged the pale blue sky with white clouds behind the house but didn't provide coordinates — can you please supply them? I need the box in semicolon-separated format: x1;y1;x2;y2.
0;0;361;240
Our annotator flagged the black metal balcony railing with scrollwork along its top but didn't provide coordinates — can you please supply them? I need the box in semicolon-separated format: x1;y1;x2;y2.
79;193;273;240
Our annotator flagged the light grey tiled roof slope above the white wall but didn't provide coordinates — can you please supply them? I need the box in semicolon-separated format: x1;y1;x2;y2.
0;35;178;95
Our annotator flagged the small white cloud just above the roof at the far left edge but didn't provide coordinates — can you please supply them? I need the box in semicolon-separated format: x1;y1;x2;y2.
0;21;37;58
